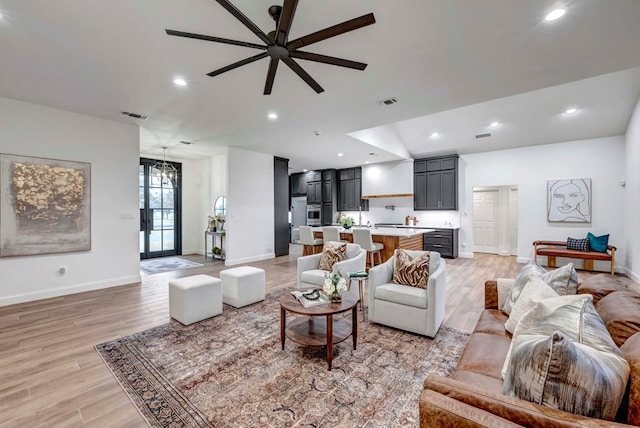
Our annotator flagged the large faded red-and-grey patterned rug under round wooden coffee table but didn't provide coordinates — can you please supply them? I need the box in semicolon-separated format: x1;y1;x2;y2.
96;290;469;427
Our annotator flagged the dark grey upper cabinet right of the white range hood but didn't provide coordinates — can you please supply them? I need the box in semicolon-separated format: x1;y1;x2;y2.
413;155;458;211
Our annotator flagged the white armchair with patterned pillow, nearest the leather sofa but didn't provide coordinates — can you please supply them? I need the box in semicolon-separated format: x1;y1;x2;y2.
369;250;447;337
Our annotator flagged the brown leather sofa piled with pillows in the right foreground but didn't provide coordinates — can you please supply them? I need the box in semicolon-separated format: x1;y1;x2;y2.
420;274;640;427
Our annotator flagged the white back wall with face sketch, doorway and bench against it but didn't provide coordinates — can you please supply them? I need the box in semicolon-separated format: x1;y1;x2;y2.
459;137;630;271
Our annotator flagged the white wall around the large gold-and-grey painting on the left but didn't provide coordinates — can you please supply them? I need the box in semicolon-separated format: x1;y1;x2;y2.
0;97;140;305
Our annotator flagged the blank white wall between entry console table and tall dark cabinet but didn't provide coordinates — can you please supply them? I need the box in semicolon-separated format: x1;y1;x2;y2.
225;147;275;265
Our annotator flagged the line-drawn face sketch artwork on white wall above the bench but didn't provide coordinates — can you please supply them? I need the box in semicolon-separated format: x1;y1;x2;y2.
547;178;591;223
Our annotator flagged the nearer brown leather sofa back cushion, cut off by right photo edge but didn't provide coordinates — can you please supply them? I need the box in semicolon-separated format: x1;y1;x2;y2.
596;290;640;346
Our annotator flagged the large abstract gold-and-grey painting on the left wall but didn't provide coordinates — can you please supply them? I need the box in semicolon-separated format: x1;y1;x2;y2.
0;154;91;257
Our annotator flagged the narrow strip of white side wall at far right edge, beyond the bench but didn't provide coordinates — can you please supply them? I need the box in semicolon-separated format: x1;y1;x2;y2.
620;100;640;281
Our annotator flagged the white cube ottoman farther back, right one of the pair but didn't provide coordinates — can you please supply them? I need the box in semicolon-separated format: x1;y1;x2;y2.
220;266;264;308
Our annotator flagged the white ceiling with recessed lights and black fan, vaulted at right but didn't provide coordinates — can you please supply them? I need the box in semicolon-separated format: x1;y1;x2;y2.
0;0;640;171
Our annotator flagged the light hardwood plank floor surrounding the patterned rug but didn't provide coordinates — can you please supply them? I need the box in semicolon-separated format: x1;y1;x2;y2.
0;245;636;427
